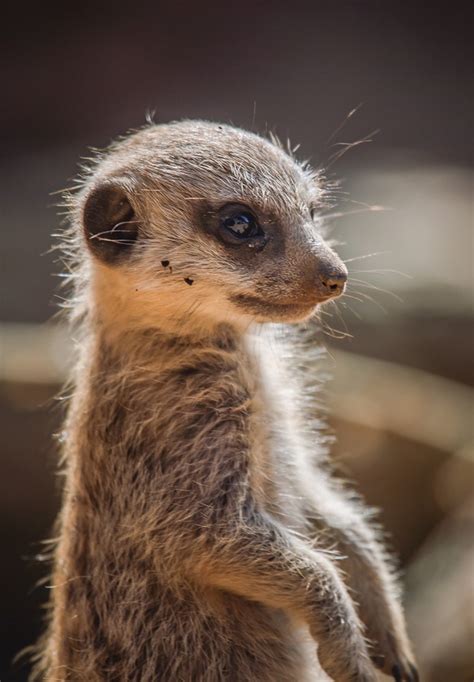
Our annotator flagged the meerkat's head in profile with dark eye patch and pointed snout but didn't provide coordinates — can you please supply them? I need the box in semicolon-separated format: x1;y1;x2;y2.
76;121;347;334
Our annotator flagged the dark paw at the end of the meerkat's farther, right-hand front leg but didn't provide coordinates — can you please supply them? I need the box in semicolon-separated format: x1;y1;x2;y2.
371;632;420;682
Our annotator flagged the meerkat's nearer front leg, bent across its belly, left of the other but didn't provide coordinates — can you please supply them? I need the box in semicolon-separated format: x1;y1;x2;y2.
186;514;376;682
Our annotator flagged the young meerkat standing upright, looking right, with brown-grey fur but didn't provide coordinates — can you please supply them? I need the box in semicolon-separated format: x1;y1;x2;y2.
36;121;418;682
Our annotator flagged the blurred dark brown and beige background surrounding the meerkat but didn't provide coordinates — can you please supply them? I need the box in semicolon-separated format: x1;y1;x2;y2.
0;0;474;682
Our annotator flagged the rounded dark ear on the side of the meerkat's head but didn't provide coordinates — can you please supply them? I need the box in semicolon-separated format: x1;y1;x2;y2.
83;184;138;264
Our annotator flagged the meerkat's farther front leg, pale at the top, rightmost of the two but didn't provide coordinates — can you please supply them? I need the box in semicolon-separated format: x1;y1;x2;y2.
308;484;419;682
